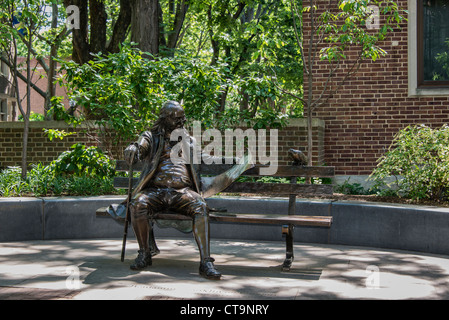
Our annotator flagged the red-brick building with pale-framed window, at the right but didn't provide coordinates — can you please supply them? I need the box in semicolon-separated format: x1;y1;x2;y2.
303;0;449;182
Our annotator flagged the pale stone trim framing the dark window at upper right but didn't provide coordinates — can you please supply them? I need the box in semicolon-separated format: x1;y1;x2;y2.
407;0;449;97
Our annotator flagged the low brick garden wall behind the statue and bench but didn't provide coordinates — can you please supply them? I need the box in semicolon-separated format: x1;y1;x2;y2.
0;119;324;168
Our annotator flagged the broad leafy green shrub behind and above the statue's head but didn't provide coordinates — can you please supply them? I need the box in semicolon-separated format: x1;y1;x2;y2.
57;45;285;136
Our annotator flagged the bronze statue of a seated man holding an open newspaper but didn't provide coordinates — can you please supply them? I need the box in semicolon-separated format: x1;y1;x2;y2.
107;101;252;279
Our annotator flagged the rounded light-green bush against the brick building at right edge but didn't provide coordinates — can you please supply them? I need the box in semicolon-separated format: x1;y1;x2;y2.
371;125;449;200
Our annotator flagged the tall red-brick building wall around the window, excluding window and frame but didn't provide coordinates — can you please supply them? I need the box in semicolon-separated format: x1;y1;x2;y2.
303;0;449;175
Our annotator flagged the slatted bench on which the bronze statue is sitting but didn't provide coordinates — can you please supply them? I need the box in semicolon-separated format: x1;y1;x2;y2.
96;160;334;271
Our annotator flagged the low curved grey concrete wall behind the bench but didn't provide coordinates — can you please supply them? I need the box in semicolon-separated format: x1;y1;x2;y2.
0;197;449;254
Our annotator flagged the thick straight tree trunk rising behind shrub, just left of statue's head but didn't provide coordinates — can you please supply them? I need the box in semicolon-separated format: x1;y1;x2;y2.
130;0;159;56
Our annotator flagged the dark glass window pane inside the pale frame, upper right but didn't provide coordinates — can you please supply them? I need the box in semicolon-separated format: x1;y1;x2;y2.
417;0;449;88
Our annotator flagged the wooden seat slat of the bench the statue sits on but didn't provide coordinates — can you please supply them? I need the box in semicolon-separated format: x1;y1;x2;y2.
96;208;332;227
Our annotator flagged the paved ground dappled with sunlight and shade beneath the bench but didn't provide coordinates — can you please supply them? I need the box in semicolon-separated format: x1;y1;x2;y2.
0;239;449;300
